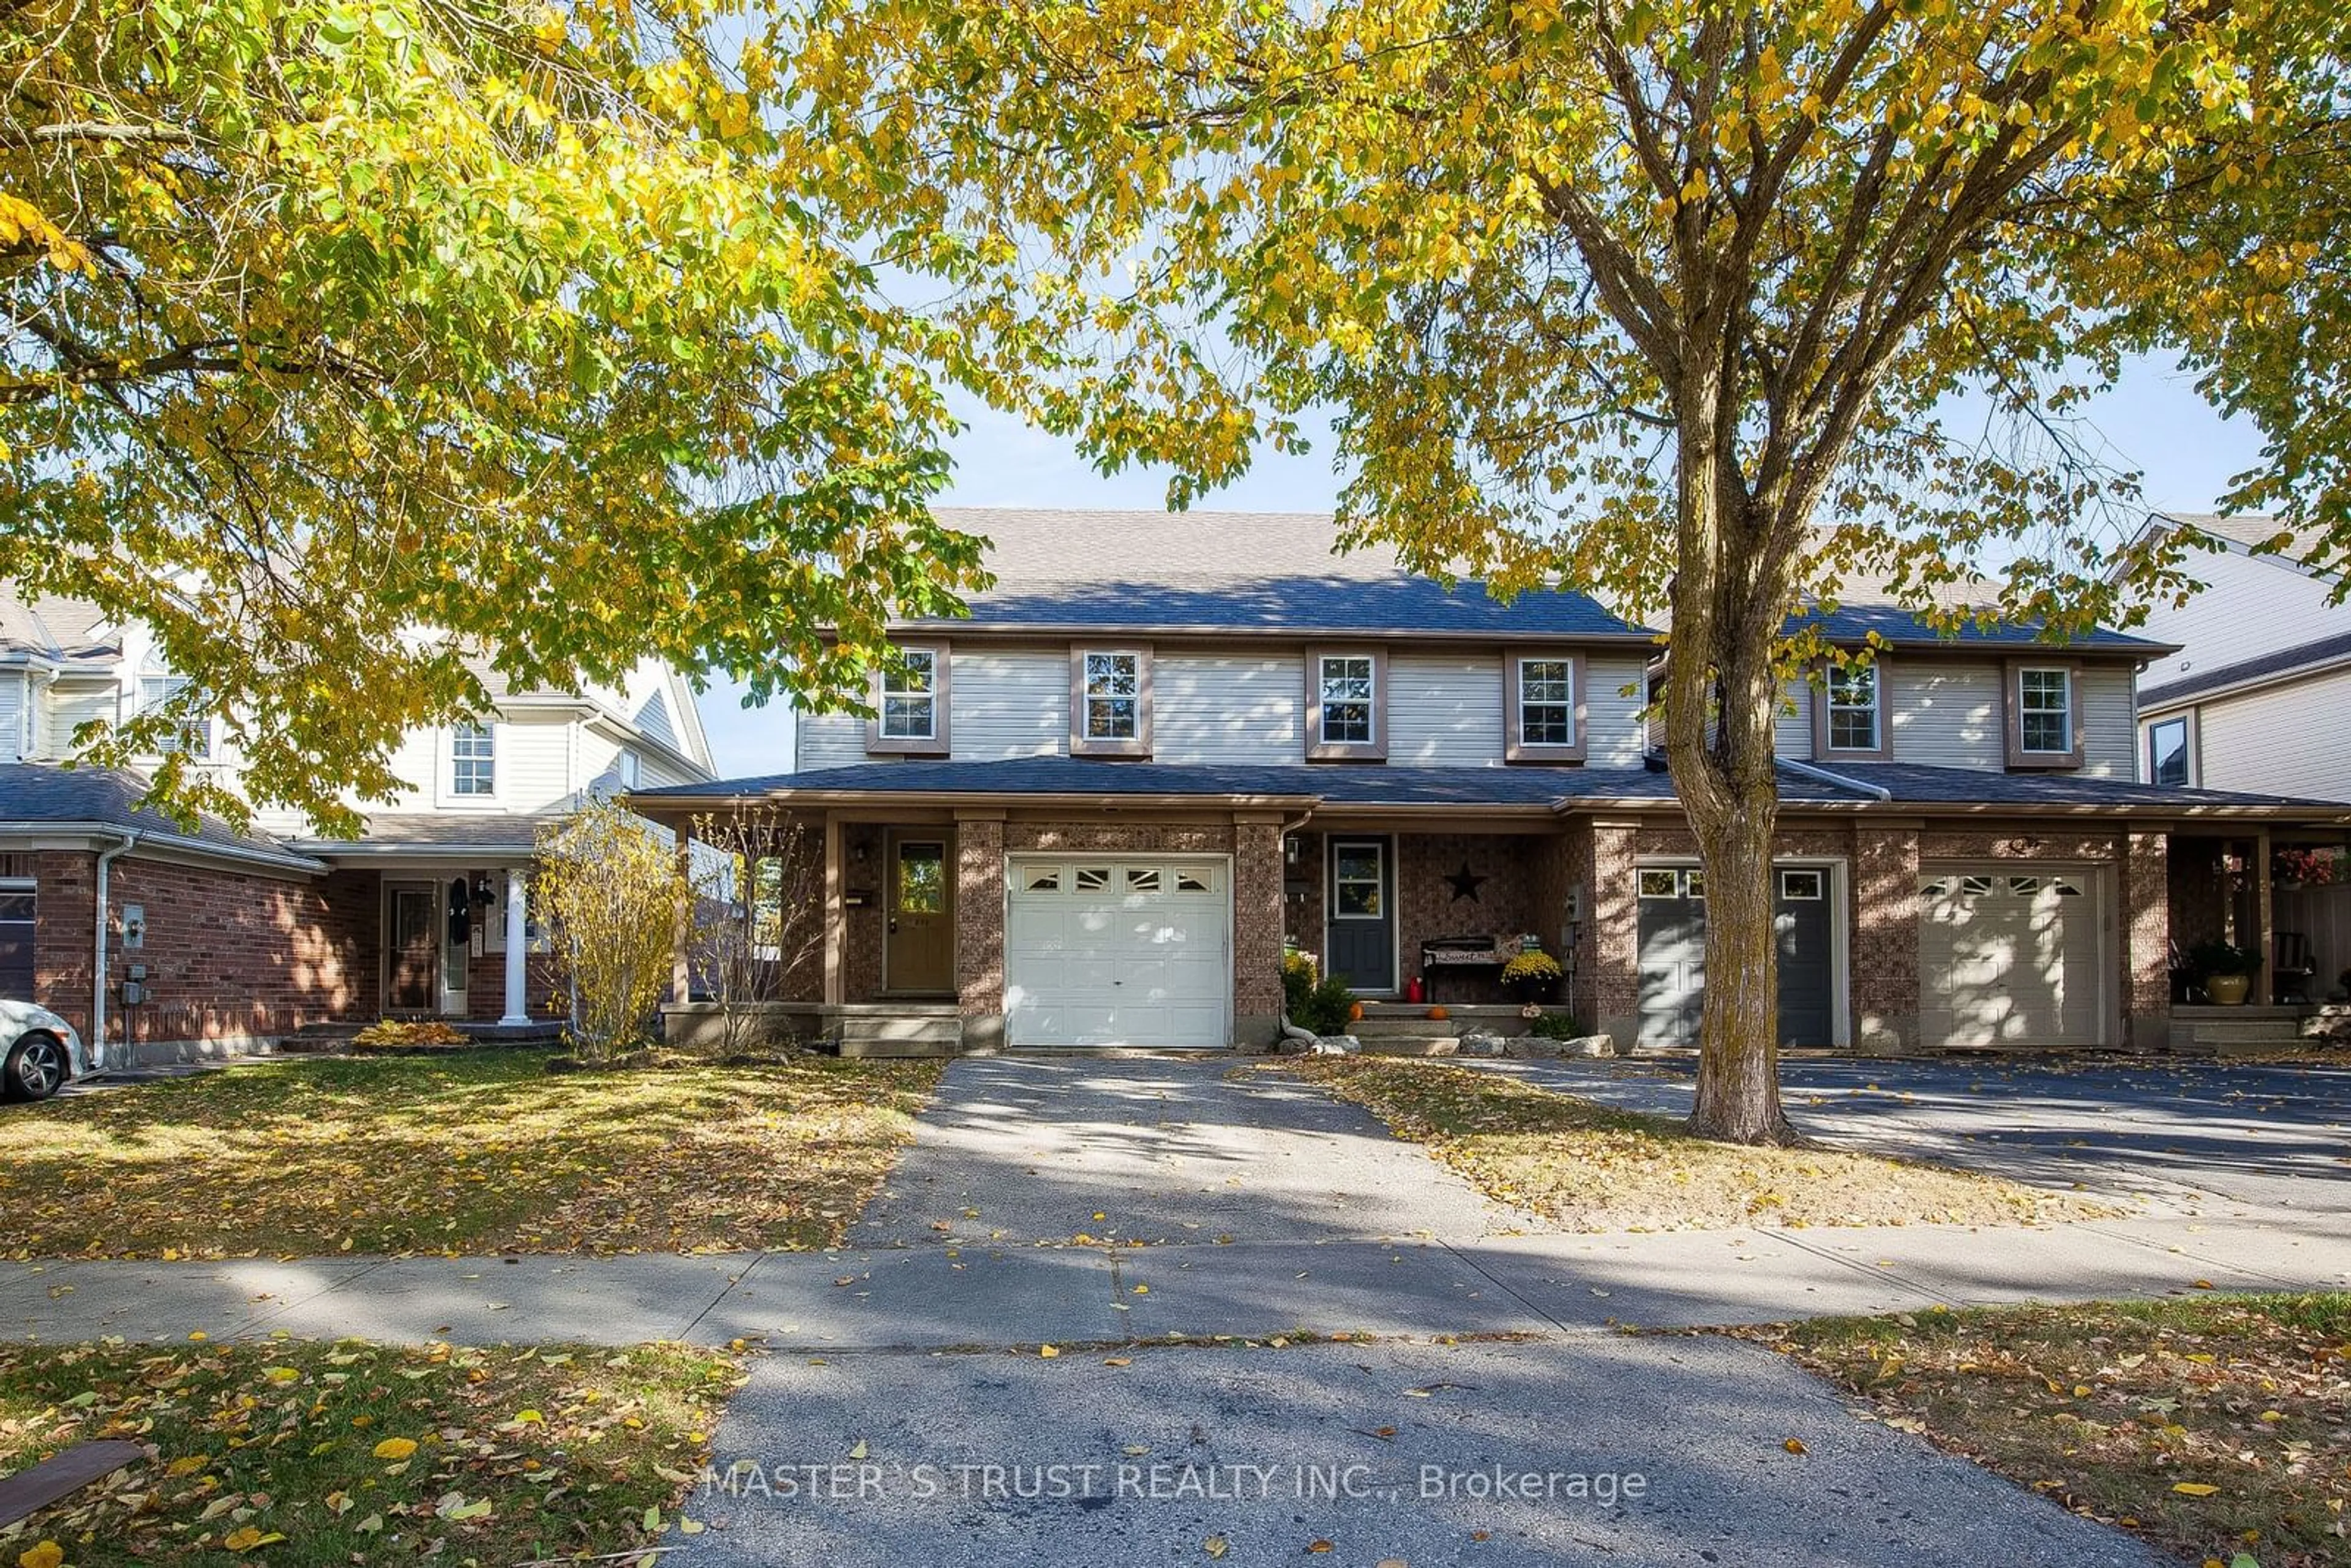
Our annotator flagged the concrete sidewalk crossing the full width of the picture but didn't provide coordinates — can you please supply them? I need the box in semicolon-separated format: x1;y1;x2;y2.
0;1218;2351;1349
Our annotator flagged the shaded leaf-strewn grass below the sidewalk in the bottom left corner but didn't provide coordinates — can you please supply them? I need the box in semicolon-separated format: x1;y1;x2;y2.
0;1340;743;1568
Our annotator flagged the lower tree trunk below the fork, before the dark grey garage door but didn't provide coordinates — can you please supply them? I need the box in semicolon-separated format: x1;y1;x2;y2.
1690;795;1796;1142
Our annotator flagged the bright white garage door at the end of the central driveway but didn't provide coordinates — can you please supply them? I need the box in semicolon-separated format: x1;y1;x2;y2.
1004;856;1232;1046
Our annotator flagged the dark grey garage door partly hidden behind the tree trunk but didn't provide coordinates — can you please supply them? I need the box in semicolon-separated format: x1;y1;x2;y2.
1637;865;1836;1046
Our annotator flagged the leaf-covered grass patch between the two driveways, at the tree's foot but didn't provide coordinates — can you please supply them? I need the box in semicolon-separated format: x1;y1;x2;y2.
1281;1056;2113;1232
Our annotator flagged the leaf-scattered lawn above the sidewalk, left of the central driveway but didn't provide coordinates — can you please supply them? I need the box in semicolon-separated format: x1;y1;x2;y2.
0;1051;938;1260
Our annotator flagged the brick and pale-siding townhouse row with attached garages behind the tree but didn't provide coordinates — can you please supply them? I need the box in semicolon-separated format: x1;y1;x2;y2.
632;510;2351;1048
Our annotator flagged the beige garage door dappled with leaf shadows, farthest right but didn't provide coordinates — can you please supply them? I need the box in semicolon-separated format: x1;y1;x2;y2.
1918;868;2107;1048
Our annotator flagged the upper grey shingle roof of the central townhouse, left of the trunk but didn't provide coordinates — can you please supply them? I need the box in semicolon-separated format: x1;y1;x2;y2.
901;508;1651;642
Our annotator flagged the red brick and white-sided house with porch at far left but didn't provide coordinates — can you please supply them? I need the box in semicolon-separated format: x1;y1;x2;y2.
0;597;713;1060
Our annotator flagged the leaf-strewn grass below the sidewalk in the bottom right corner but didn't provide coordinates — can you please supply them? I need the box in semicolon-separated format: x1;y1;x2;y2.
1742;1293;2351;1568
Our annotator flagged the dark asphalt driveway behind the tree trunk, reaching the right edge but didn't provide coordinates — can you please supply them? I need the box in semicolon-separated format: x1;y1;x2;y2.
1479;1058;2351;1215
